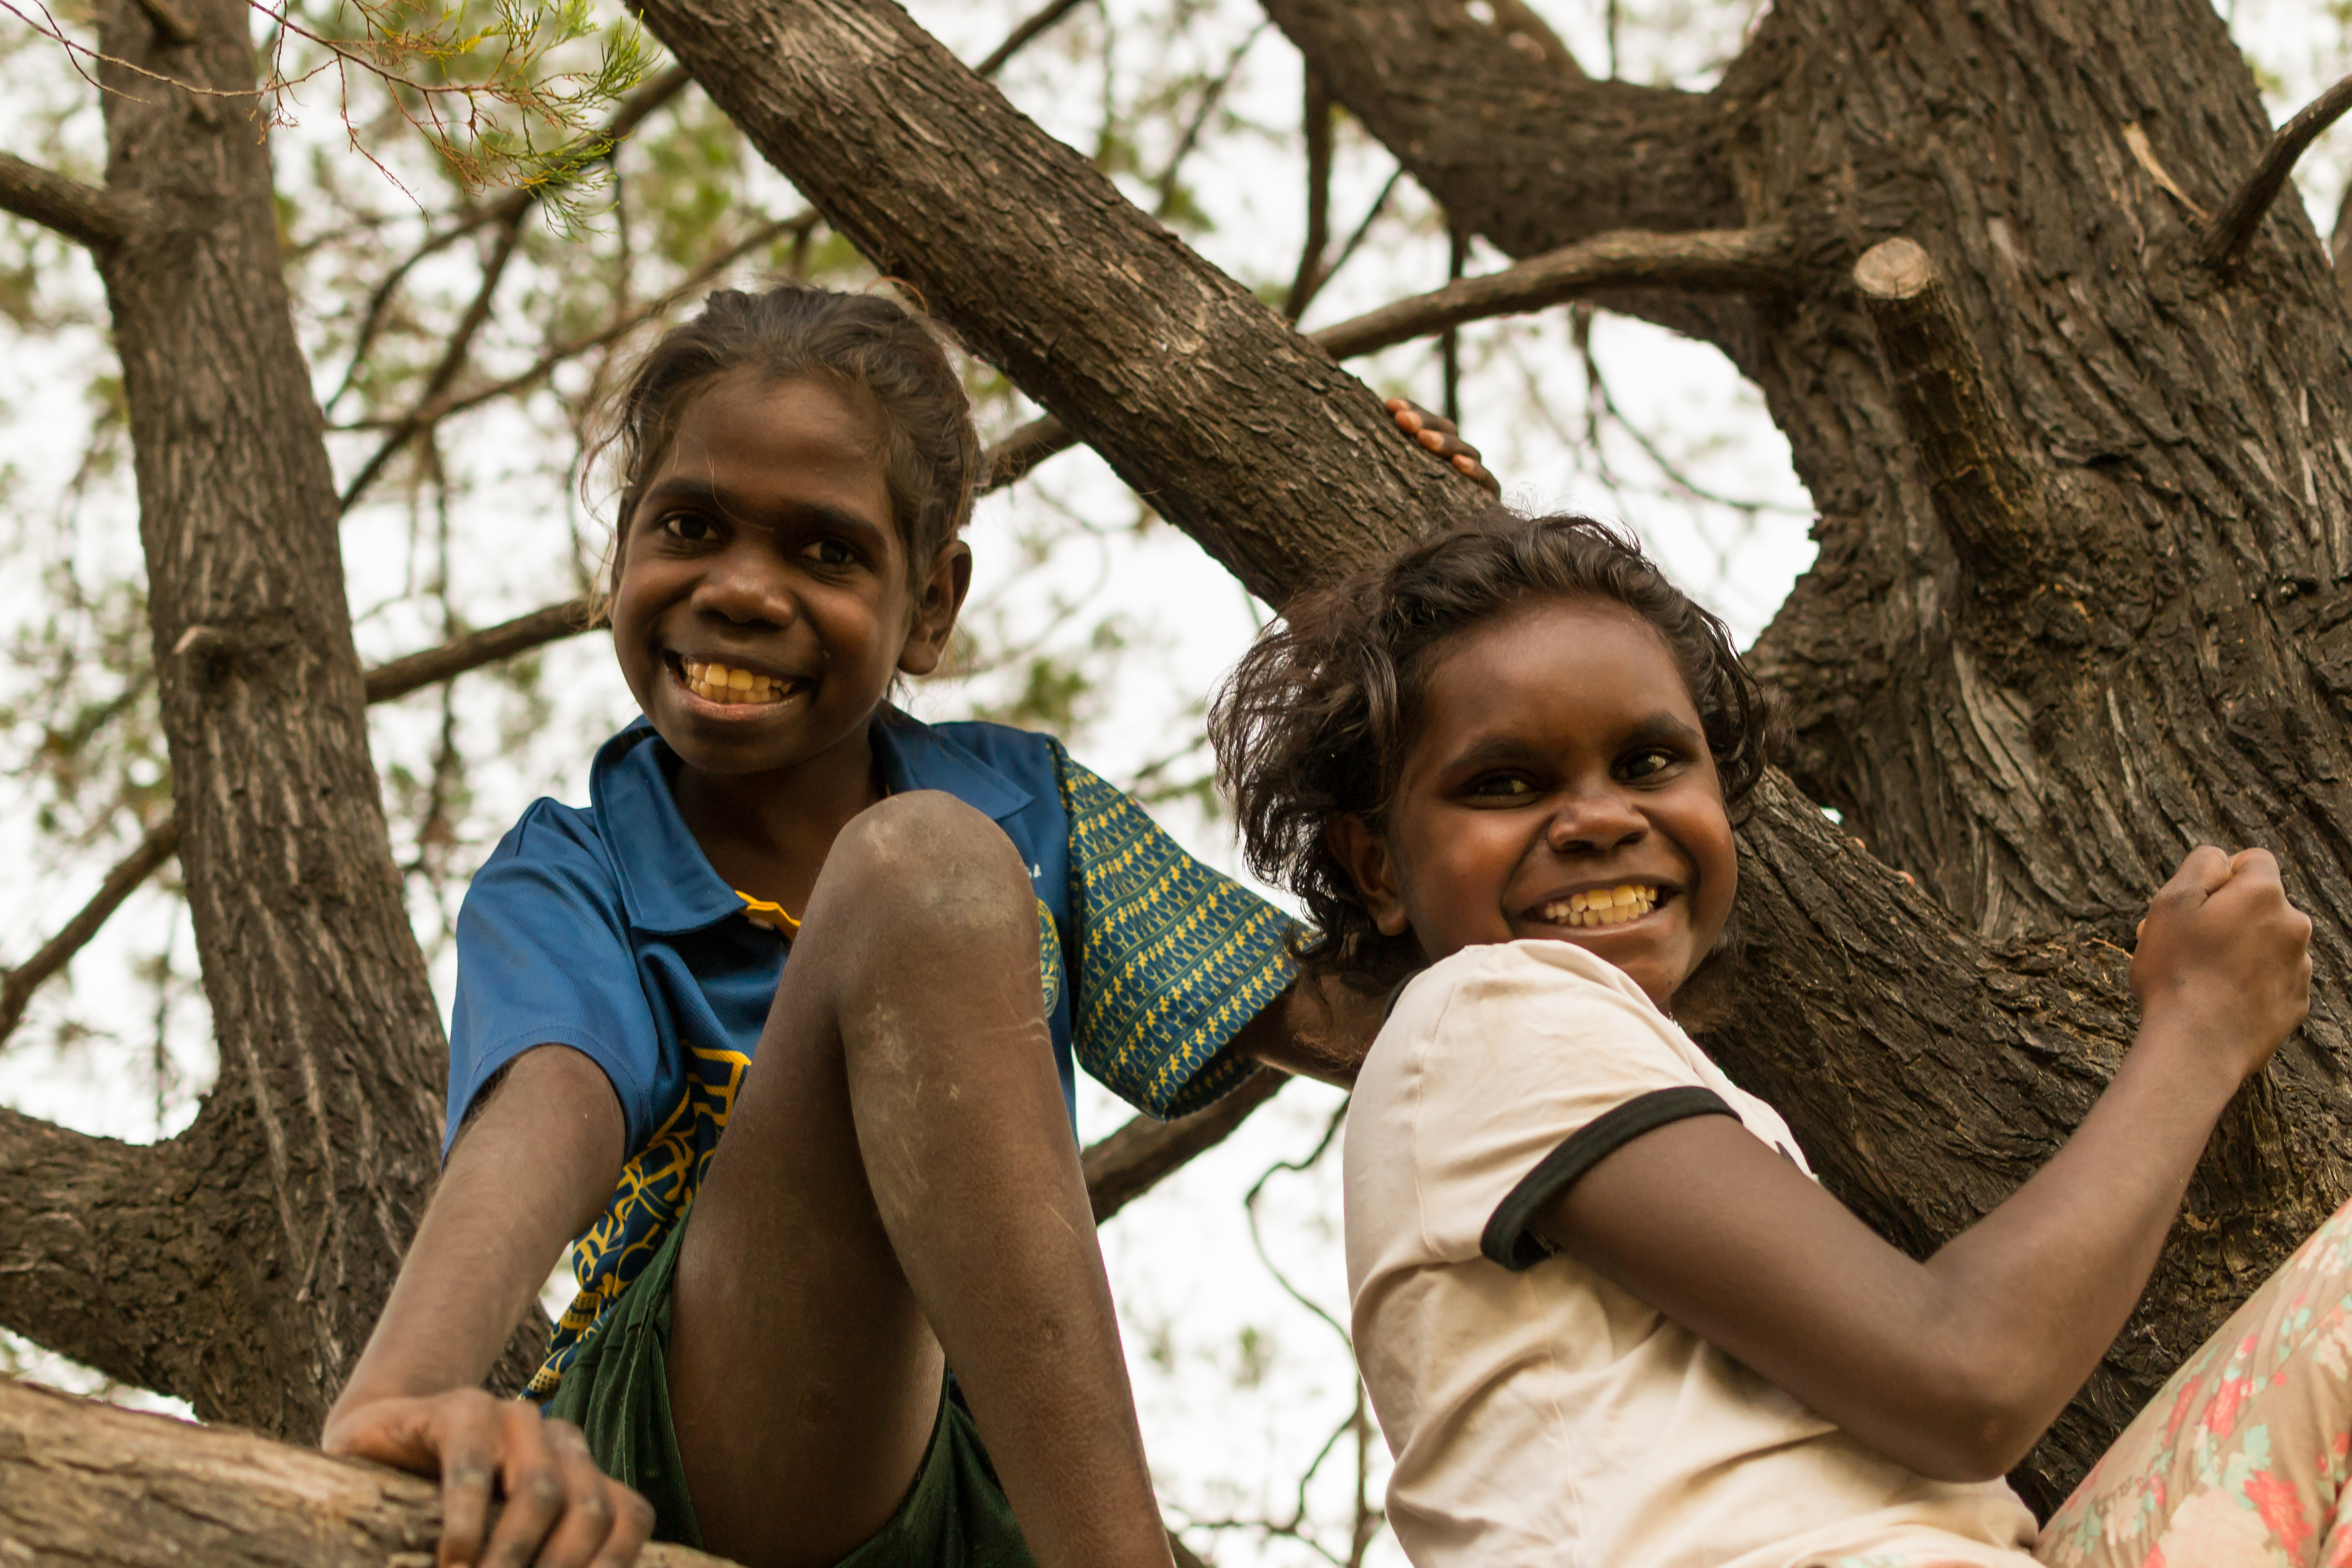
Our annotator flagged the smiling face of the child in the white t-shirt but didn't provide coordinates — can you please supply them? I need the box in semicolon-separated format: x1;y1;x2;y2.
1331;599;1738;1009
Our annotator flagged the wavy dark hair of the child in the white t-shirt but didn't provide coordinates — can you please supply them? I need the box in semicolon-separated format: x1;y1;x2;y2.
1209;508;1780;985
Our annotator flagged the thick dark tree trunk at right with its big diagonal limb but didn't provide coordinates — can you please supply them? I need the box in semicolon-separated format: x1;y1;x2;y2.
645;0;2352;1502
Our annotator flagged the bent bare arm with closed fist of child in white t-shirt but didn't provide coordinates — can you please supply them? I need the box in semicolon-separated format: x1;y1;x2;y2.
1533;849;2310;1481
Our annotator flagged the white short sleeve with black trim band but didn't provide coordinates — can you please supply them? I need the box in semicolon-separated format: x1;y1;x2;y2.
1390;943;1738;1269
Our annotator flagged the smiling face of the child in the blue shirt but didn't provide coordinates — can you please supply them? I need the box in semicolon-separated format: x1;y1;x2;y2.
611;372;971;773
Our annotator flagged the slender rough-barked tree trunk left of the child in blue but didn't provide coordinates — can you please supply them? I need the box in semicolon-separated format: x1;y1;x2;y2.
0;0;458;1436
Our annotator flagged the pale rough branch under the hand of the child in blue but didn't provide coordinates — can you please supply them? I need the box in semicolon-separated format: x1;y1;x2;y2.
0;1380;724;1568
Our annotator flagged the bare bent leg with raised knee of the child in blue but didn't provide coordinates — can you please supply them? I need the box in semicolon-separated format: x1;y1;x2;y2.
670;792;1169;1568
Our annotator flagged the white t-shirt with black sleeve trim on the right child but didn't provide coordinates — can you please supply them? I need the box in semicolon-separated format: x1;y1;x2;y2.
1345;943;2035;1568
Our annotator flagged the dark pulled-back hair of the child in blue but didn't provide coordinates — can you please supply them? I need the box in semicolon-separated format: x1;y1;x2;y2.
595;284;981;597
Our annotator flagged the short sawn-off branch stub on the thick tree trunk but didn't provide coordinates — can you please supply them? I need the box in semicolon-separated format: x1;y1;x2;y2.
1853;237;2049;578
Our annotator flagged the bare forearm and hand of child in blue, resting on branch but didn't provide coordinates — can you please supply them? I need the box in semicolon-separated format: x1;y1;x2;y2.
320;1046;651;1568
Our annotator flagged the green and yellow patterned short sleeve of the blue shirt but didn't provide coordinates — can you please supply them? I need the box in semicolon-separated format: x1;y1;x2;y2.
1054;745;1298;1117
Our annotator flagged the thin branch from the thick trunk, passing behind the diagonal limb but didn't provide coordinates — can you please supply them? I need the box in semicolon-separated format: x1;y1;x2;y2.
981;226;1797;496
